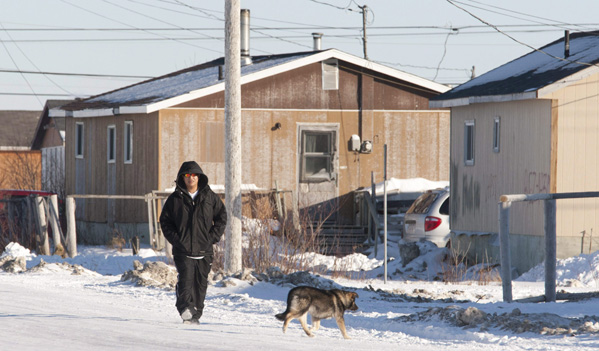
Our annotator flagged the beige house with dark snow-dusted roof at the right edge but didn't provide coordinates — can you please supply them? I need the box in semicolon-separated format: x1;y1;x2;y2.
430;32;599;274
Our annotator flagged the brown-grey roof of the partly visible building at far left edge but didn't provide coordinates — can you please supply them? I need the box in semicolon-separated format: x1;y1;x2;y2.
0;111;42;148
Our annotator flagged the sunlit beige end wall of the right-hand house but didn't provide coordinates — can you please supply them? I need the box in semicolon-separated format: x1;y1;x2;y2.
550;74;599;241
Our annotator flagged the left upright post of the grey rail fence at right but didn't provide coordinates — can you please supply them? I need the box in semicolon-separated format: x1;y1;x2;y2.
499;201;512;302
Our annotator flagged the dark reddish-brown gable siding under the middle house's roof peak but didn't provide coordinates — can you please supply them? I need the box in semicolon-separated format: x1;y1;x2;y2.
177;61;436;110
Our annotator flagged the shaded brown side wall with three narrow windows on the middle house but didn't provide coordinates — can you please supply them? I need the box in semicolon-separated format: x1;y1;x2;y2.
65;113;159;222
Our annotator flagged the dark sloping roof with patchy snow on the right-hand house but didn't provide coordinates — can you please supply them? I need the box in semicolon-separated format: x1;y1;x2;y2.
430;31;599;107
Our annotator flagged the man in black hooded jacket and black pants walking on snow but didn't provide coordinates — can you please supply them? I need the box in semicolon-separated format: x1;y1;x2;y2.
160;161;227;324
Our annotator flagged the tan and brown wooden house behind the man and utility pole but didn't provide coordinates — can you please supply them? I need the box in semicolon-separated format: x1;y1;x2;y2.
51;49;449;248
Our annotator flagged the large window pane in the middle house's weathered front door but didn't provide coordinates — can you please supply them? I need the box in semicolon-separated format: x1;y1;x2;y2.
300;131;335;183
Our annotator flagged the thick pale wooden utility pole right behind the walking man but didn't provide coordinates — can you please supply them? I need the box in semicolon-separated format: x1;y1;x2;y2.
225;0;243;273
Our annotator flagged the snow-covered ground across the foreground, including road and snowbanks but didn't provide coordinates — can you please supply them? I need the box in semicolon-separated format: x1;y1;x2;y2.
0;239;599;351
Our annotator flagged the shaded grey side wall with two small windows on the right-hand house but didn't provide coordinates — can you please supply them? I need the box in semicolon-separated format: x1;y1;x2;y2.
450;100;552;235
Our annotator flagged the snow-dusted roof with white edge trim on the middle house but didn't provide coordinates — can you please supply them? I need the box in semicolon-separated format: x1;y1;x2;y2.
51;49;449;117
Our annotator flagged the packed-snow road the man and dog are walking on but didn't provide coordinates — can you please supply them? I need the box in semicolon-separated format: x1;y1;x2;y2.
0;271;599;351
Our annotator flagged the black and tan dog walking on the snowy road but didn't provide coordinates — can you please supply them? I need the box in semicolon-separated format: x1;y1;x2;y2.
275;286;358;339
